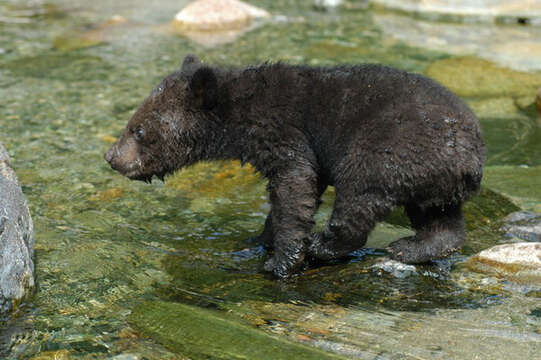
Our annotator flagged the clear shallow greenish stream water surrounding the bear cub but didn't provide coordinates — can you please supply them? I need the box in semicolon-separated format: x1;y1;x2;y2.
0;0;541;359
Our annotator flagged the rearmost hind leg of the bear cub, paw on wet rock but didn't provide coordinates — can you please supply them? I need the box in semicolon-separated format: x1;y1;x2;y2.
388;204;465;264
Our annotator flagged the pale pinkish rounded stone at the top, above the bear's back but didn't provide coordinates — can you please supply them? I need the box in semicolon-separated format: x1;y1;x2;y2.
175;0;269;31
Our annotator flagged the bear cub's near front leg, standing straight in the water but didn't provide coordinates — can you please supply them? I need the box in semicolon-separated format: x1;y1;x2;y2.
264;164;319;278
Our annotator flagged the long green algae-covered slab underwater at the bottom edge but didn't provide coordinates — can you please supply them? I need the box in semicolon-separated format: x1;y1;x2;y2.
130;301;343;360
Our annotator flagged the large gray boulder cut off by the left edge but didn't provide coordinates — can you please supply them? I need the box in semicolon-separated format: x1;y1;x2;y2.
0;144;34;314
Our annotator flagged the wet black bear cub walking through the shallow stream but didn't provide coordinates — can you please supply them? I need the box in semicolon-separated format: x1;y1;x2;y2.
105;55;485;277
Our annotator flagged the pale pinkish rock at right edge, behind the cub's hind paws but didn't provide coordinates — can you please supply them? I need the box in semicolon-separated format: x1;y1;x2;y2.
469;243;541;282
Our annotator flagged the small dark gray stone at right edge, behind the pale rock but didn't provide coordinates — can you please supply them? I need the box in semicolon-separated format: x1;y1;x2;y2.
501;211;541;242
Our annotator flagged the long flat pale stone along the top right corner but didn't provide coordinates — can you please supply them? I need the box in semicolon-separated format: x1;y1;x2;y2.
371;0;541;23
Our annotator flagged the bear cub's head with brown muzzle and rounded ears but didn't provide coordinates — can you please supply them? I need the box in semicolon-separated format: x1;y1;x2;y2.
105;55;220;182
